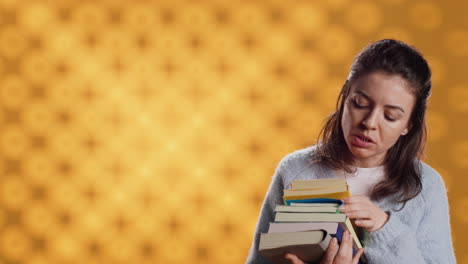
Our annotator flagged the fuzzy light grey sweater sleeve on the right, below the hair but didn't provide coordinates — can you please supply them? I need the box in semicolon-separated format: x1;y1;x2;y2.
364;168;456;264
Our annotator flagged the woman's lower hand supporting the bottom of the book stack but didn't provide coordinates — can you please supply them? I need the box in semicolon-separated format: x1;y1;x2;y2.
284;231;364;264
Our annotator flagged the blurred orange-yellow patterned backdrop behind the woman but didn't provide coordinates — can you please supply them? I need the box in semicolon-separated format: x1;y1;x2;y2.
0;0;468;264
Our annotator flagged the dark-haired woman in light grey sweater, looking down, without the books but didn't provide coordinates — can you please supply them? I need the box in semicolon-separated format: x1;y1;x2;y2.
247;39;456;264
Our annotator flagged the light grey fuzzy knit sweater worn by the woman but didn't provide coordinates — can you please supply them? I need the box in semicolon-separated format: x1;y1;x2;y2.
246;146;456;264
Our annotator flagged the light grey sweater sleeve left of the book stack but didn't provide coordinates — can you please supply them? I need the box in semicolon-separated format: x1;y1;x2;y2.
246;156;285;264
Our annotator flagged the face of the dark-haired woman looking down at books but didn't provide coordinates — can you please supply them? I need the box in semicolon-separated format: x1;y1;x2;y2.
341;72;415;167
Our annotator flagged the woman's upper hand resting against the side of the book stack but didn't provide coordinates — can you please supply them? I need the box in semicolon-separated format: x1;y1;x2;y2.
339;195;388;232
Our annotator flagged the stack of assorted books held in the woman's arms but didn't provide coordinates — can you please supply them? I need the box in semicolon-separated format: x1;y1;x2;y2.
259;179;365;264
